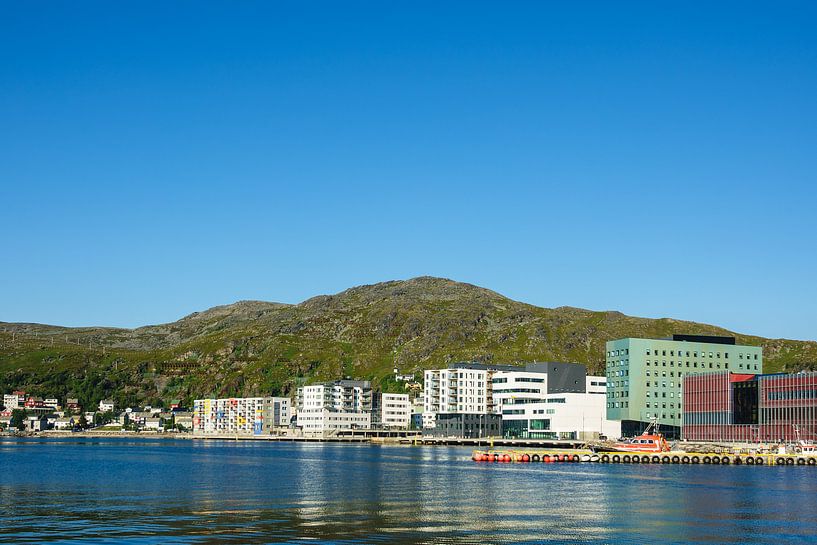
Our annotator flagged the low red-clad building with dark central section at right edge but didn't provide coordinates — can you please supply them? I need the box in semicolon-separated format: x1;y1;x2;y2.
682;370;817;443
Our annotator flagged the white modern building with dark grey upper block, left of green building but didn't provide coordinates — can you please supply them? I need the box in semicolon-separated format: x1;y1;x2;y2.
491;362;621;440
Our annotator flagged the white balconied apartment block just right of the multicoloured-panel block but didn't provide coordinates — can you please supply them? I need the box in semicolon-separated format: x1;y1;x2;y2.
296;380;372;433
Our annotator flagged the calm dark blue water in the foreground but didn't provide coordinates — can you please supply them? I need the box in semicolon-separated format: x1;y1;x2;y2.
0;439;817;544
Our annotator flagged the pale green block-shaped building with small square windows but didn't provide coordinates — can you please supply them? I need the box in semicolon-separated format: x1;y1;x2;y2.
606;335;763;438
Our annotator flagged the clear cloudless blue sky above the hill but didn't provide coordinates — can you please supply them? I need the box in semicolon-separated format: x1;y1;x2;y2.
0;1;817;339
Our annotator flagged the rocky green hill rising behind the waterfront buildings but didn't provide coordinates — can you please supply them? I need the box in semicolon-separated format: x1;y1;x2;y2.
0;277;817;406
